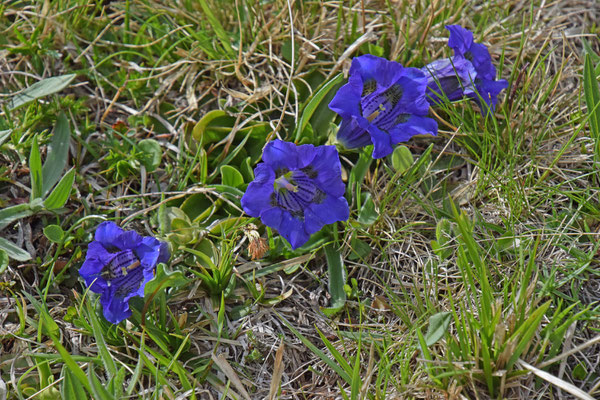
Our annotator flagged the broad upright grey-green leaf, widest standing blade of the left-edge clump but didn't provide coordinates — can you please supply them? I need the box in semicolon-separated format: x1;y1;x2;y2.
42;112;71;195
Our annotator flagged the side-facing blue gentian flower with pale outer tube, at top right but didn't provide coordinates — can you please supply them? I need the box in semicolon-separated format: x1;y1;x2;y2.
422;25;508;114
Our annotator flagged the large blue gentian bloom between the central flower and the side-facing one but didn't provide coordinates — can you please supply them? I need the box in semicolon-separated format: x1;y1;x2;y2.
329;54;437;158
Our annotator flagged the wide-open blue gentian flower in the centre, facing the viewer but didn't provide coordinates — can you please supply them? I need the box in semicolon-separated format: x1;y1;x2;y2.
242;140;350;249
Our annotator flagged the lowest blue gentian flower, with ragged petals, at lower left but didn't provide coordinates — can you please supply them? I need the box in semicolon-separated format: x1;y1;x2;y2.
79;221;170;324
